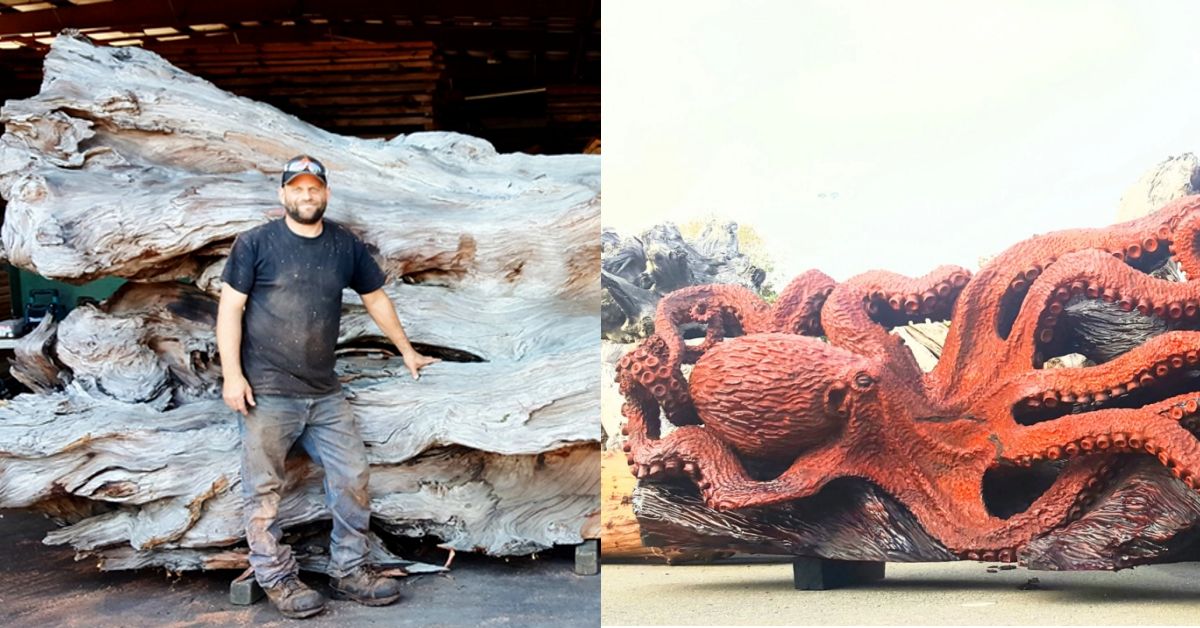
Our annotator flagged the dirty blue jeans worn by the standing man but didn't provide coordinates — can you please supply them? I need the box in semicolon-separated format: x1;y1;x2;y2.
238;393;371;586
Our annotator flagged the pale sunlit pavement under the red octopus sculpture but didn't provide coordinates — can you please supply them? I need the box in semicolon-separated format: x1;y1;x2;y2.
601;563;1200;626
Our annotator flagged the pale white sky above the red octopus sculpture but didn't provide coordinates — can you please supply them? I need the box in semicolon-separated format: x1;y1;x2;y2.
602;0;1200;287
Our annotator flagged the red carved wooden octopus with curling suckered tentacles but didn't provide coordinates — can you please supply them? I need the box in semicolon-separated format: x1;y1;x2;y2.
617;196;1200;562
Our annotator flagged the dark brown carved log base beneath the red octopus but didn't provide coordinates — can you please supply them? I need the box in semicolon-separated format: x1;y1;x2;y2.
632;461;1200;570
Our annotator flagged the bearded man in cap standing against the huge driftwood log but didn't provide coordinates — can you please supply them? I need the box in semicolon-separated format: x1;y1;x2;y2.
217;155;438;617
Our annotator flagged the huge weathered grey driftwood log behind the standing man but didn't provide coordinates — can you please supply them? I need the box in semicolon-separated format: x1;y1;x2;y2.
0;36;600;569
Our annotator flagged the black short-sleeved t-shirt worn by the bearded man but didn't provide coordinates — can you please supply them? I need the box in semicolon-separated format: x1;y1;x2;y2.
221;219;386;396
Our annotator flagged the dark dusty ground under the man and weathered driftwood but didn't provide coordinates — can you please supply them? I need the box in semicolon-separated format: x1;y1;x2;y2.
0;510;600;628
